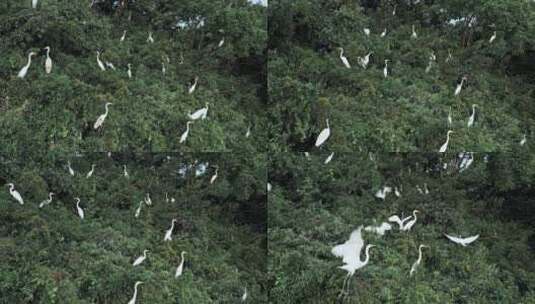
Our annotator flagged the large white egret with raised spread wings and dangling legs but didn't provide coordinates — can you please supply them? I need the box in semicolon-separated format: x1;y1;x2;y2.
331;226;375;294
